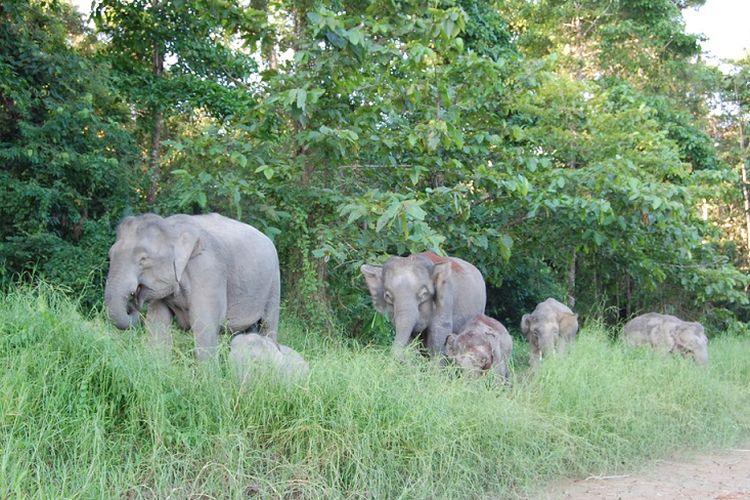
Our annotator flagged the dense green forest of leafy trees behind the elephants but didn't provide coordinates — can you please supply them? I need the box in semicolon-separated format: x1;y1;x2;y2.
0;0;750;343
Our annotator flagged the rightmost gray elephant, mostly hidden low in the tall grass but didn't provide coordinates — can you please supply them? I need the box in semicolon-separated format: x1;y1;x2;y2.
622;313;708;365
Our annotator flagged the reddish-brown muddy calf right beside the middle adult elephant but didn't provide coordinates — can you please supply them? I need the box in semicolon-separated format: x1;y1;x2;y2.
445;314;513;380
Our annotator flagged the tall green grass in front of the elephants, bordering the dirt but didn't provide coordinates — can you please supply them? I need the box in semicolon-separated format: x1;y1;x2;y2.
0;289;750;499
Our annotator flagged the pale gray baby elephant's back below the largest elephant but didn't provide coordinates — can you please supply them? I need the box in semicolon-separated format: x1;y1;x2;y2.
229;333;310;384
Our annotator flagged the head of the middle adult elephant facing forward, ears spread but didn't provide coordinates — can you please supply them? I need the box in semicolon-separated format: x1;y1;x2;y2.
360;255;451;350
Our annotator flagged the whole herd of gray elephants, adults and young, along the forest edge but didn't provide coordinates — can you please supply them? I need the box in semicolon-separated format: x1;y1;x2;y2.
105;214;708;379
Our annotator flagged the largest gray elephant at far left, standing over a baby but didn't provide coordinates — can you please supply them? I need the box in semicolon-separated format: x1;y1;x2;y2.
104;214;280;360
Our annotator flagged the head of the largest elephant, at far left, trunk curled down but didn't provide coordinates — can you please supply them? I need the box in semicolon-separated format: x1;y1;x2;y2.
104;214;200;330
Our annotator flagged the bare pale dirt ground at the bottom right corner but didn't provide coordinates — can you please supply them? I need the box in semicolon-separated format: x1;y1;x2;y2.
529;445;750;500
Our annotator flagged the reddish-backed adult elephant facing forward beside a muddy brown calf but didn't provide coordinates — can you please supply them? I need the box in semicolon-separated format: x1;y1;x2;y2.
361;252;487;358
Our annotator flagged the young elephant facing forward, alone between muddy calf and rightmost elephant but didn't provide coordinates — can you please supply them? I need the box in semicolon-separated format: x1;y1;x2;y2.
521;298;578;367
